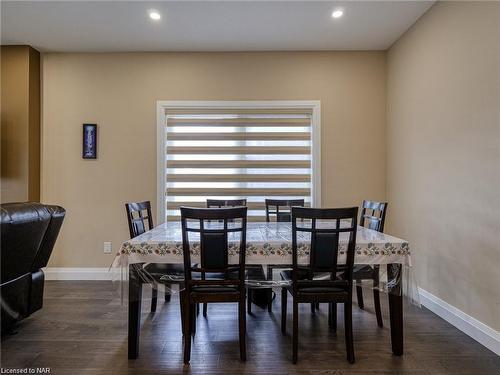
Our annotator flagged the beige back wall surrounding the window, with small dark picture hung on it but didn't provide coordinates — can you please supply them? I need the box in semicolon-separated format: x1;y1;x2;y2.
42;52;386;267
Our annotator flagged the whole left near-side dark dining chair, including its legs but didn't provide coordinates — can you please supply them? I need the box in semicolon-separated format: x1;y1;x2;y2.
181;207;247;364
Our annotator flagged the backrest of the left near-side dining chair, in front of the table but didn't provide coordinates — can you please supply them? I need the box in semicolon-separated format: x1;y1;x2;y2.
181;207;247;287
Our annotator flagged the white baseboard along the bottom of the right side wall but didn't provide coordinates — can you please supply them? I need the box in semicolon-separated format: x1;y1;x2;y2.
418;288;500;355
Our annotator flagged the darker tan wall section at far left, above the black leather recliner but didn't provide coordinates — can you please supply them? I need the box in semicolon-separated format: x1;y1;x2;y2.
0;46;40;202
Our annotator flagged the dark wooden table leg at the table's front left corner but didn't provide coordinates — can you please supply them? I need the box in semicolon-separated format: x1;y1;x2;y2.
128;264;142;359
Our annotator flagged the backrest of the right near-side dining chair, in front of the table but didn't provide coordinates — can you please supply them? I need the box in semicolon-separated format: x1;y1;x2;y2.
292;207;358;288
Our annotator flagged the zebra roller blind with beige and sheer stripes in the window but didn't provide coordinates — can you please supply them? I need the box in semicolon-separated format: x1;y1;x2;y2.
165;109;312;221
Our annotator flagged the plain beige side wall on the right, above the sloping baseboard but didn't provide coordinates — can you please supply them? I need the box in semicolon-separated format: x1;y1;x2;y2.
387;2;500;330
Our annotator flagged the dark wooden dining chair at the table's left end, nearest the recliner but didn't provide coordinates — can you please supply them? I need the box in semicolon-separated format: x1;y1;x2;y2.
125;201;184;312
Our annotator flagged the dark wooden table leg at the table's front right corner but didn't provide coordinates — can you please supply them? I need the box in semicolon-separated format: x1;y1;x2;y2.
387;264;403;356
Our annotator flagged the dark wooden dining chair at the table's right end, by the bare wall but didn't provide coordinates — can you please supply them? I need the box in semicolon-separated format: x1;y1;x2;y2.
353;200;388;327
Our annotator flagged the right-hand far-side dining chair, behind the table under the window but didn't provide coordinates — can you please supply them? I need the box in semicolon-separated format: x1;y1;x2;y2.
247;198;304;314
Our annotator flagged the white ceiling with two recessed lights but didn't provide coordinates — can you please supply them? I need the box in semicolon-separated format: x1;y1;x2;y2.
1;1;433;52
